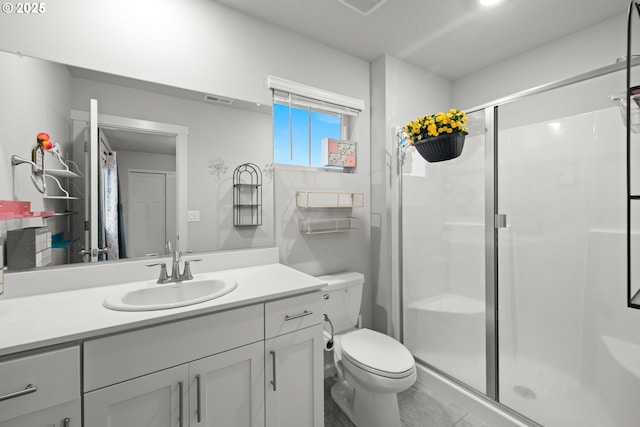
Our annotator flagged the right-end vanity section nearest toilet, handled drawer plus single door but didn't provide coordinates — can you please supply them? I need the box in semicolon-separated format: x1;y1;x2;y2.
265;292;324;427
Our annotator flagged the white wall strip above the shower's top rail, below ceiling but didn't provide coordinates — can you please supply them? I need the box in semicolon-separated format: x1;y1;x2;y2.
453;14;627;108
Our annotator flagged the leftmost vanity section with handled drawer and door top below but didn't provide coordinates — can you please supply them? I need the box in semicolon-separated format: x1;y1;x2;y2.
0;346;81;427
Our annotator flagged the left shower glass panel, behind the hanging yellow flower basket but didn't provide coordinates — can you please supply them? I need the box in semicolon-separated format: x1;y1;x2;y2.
402;111;487;393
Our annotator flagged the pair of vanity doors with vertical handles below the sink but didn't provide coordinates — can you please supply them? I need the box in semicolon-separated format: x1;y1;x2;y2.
85;342;264;427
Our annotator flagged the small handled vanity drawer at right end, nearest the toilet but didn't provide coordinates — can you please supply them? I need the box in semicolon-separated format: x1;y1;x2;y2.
264;292;322;339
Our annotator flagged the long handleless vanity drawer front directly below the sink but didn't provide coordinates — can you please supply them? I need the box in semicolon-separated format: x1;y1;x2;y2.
84;304;264;392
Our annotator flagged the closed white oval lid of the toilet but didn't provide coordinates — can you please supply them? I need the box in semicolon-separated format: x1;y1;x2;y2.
340;329;415;378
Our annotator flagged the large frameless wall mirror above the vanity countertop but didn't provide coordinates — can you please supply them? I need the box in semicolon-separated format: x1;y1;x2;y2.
0;51;274;271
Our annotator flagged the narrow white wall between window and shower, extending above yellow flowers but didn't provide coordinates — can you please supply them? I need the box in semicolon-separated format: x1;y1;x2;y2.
371;55;451;336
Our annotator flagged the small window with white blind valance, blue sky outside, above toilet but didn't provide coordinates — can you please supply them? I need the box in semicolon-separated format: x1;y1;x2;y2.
269;76;364;167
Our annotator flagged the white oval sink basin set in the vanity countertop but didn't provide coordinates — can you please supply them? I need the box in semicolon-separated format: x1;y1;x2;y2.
104;277;238;311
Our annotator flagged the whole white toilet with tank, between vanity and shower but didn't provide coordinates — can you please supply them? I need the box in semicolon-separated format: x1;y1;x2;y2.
319;272;417;427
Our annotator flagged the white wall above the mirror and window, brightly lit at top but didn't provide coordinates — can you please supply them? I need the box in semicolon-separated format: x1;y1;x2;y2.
0;0;368;113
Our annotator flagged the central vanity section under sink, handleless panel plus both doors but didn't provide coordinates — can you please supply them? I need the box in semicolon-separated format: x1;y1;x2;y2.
84;304;264;427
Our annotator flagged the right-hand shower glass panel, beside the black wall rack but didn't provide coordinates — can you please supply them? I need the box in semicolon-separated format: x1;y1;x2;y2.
497;68;640;427
